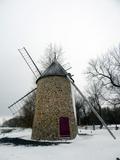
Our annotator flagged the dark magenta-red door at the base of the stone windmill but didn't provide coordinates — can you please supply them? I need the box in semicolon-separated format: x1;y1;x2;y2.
59;117;70;137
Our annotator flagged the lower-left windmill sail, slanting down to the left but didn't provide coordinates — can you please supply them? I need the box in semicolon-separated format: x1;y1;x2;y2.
8;88;37;115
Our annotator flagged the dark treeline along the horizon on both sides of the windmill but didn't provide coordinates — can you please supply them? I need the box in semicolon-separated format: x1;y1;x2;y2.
3;102;120;128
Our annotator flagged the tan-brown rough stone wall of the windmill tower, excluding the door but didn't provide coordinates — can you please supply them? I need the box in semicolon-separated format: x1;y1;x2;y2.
32;76;77;140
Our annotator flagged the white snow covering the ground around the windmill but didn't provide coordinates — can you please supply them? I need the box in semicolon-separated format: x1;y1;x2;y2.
0;126;120;160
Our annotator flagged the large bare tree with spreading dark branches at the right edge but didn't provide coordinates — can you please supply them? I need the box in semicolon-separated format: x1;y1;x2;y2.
87;45;120;105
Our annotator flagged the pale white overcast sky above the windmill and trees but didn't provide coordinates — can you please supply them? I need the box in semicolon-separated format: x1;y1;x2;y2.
0;0;120;116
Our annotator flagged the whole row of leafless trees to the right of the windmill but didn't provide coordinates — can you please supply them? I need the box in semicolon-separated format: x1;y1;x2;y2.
77;45;120;126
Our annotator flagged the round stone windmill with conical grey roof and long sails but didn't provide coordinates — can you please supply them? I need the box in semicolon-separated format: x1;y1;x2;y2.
8;47;115;140
